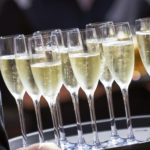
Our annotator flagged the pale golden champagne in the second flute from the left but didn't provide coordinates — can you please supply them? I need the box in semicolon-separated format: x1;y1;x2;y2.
15;56;40;98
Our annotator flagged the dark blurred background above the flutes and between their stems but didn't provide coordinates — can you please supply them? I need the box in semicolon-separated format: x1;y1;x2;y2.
0;0;150;138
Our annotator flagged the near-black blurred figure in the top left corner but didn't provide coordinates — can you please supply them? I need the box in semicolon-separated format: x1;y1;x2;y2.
0;0;33;36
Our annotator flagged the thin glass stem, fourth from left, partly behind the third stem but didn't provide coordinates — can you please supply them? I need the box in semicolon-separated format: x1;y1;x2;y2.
56;94;67;141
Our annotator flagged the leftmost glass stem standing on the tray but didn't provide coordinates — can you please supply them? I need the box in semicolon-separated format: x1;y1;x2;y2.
16;99;28;147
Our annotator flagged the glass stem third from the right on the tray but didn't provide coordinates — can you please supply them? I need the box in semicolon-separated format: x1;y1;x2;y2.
88;94;100;145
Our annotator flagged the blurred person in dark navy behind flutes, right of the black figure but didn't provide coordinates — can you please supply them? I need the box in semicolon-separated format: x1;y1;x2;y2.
14;0;150;30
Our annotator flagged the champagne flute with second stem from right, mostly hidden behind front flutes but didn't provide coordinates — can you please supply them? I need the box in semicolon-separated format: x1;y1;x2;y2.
86;21;126;147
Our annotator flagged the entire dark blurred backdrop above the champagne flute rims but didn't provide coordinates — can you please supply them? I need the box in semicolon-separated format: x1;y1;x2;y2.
0;0;150;35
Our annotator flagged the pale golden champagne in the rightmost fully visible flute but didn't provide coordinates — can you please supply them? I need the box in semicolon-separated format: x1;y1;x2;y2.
103;41;134;88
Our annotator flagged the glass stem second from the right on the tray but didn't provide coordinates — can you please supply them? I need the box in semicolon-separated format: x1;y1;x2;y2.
105;87;118;137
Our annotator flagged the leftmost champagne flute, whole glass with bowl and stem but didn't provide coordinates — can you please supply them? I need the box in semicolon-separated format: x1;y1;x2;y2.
0;36;28;147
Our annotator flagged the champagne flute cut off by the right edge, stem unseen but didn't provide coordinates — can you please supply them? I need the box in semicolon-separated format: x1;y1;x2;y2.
135;18;150;141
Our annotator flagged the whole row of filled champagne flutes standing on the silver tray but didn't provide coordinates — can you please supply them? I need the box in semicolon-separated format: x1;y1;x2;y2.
0;19;148;149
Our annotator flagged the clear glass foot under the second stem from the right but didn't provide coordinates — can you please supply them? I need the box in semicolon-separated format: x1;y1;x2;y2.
104;136;127;147
